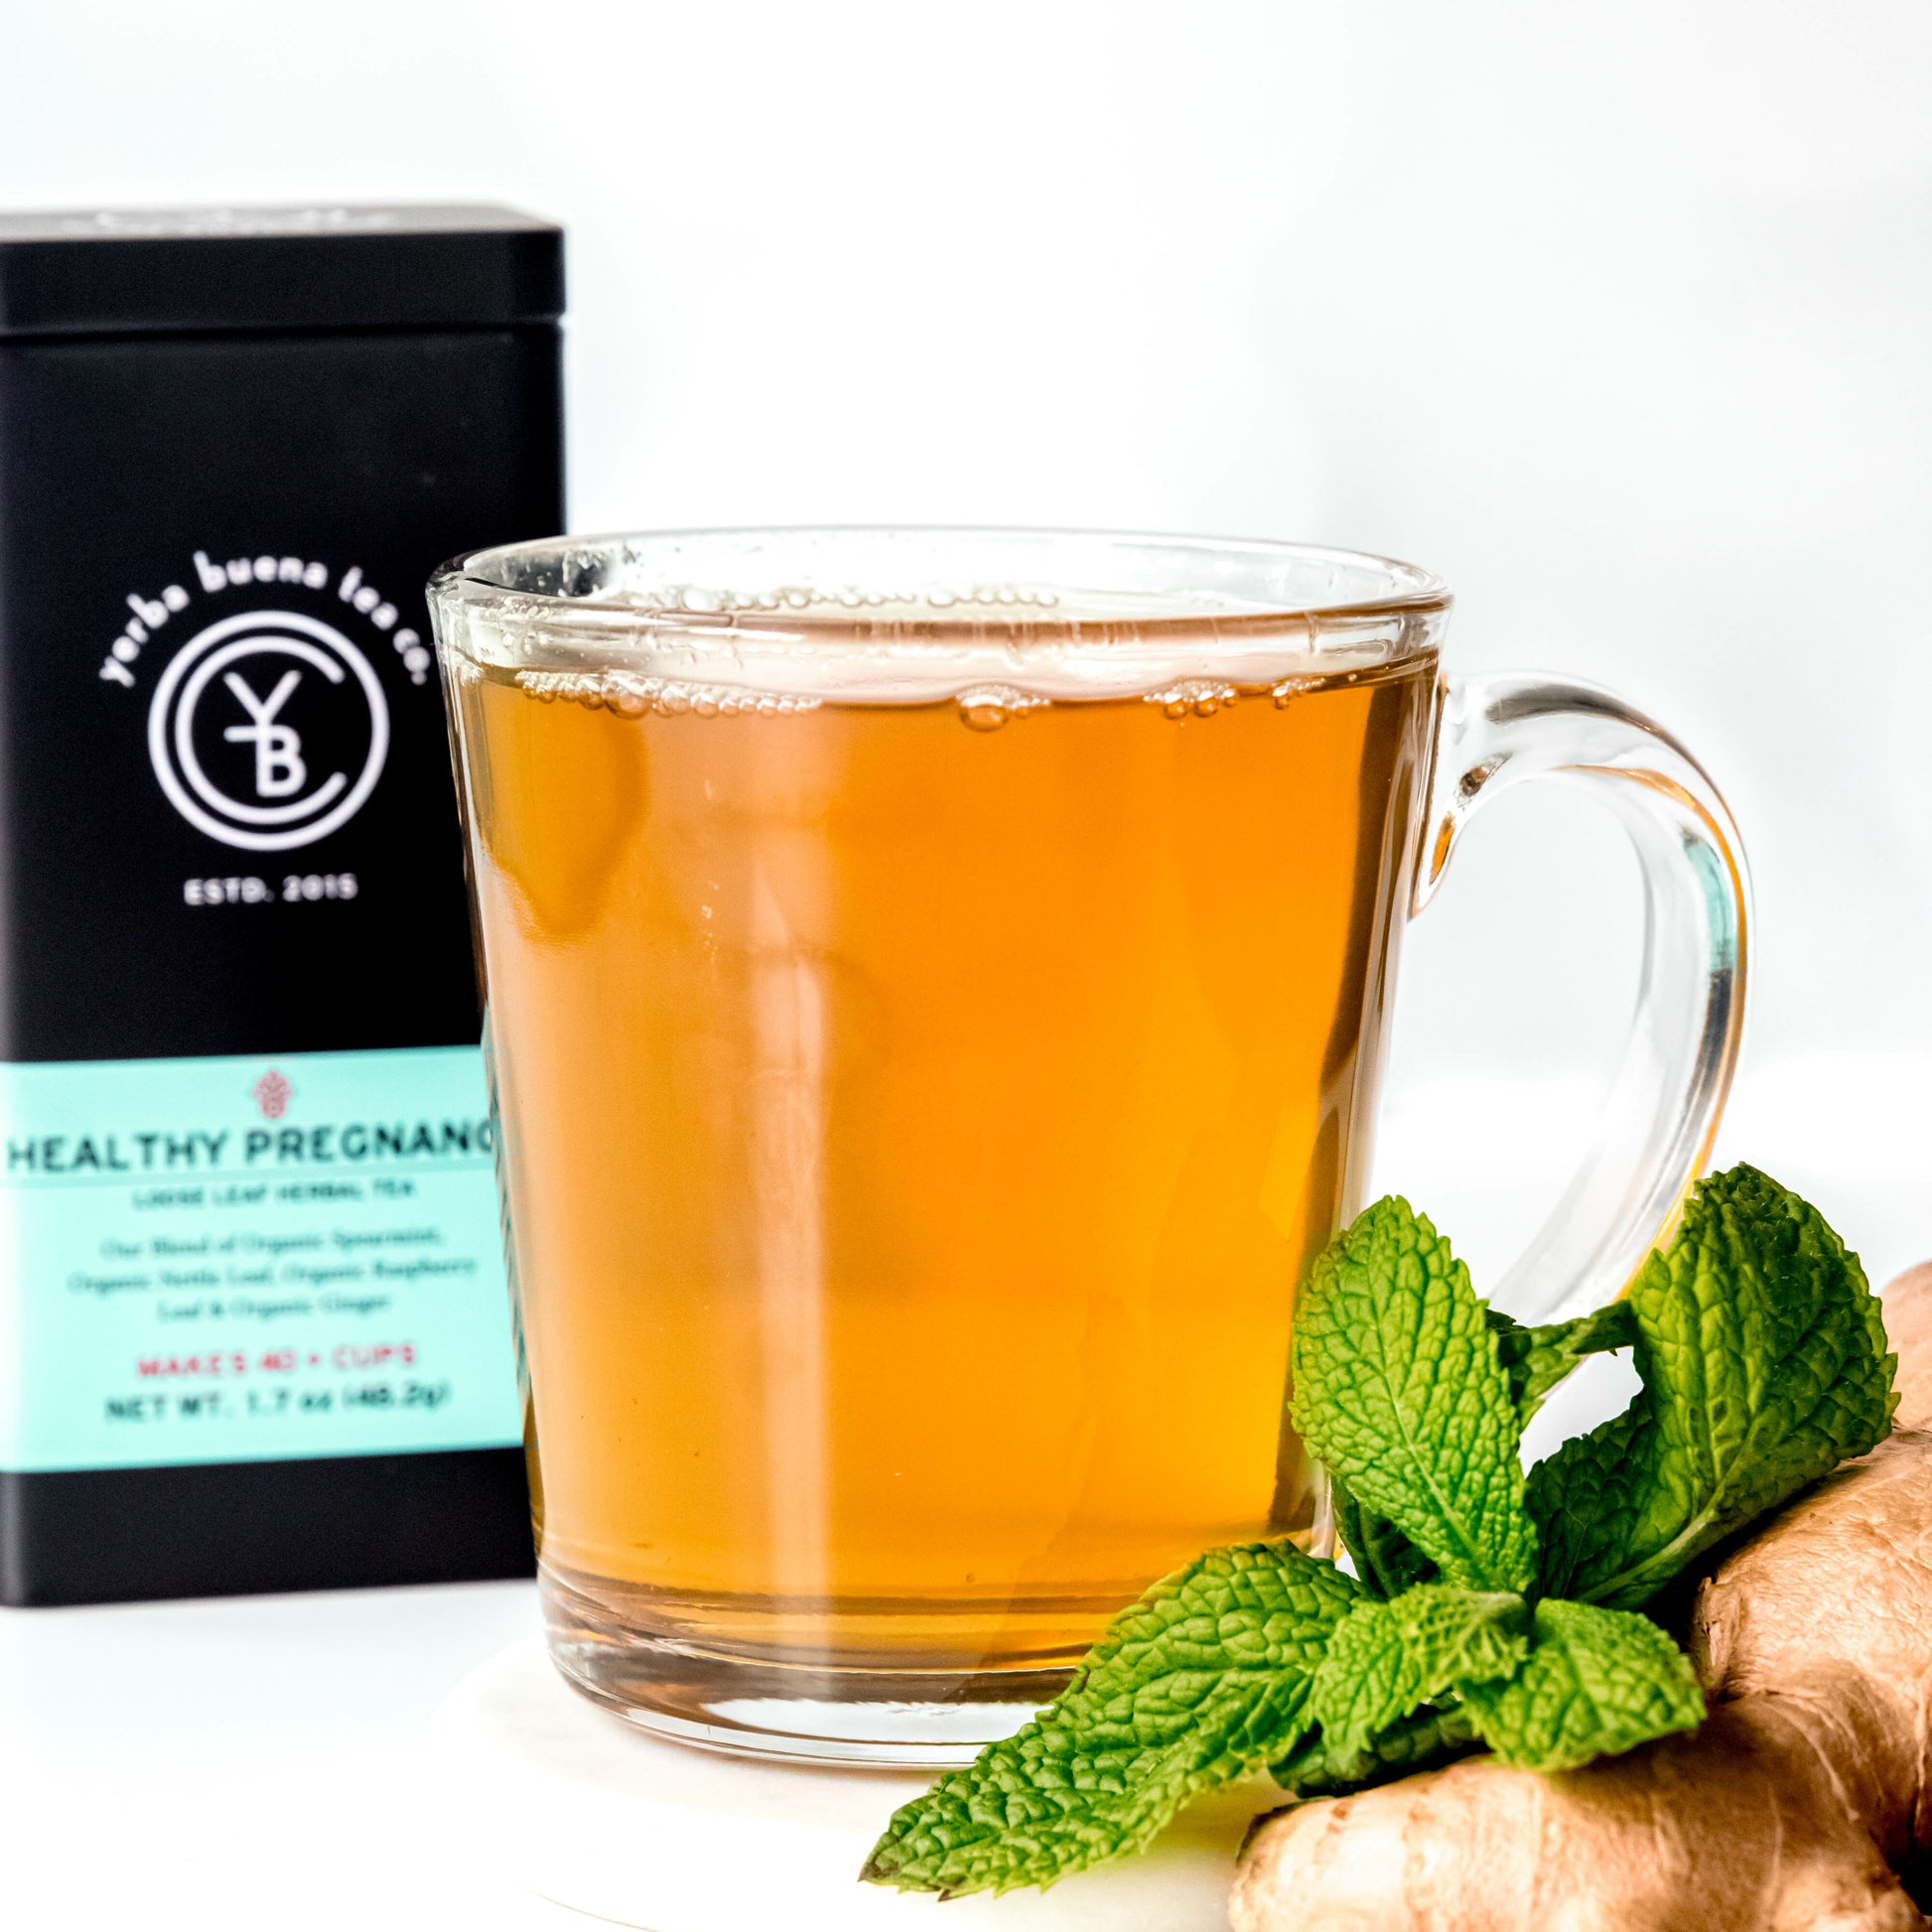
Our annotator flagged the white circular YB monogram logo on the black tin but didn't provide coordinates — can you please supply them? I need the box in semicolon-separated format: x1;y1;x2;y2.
147;611;388;852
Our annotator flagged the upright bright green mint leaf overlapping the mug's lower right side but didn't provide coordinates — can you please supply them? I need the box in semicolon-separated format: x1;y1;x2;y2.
1291;1196;1536;1592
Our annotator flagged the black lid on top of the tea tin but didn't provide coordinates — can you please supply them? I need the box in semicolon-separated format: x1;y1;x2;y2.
0;205;564;339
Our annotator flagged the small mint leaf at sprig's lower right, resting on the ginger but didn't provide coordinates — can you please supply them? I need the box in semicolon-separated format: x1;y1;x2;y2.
1462;1597;1704;1771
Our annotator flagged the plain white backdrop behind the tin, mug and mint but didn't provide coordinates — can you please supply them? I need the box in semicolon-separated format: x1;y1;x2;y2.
0;0;1932;1924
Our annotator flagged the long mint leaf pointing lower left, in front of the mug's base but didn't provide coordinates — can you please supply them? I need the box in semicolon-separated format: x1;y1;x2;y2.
860;1544;1362;1897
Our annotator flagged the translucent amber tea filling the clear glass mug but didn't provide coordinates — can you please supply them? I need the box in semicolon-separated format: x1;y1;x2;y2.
462;625;1434;1700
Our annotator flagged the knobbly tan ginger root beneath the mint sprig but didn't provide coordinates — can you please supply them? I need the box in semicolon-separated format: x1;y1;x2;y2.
1231;1264;1932;1932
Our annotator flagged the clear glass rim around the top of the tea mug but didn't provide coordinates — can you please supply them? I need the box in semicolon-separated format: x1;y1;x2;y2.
429;523;1452;643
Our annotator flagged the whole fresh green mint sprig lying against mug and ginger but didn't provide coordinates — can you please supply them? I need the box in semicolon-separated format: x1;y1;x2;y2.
862;1167;1897;1897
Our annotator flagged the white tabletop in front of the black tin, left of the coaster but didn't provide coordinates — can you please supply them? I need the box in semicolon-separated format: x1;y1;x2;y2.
0;1583;595;1932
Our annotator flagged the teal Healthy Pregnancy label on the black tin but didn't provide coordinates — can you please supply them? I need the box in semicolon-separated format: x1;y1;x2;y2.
0;1047;521;1470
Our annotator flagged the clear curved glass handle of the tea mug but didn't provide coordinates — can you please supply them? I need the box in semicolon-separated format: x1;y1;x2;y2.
1413;672;1750;1321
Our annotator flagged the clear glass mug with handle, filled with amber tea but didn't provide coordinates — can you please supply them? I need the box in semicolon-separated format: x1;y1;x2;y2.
431;529;1746;1764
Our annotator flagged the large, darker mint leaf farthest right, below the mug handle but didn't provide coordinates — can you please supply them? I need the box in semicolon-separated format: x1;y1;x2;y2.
1528;1167;1897;1609
